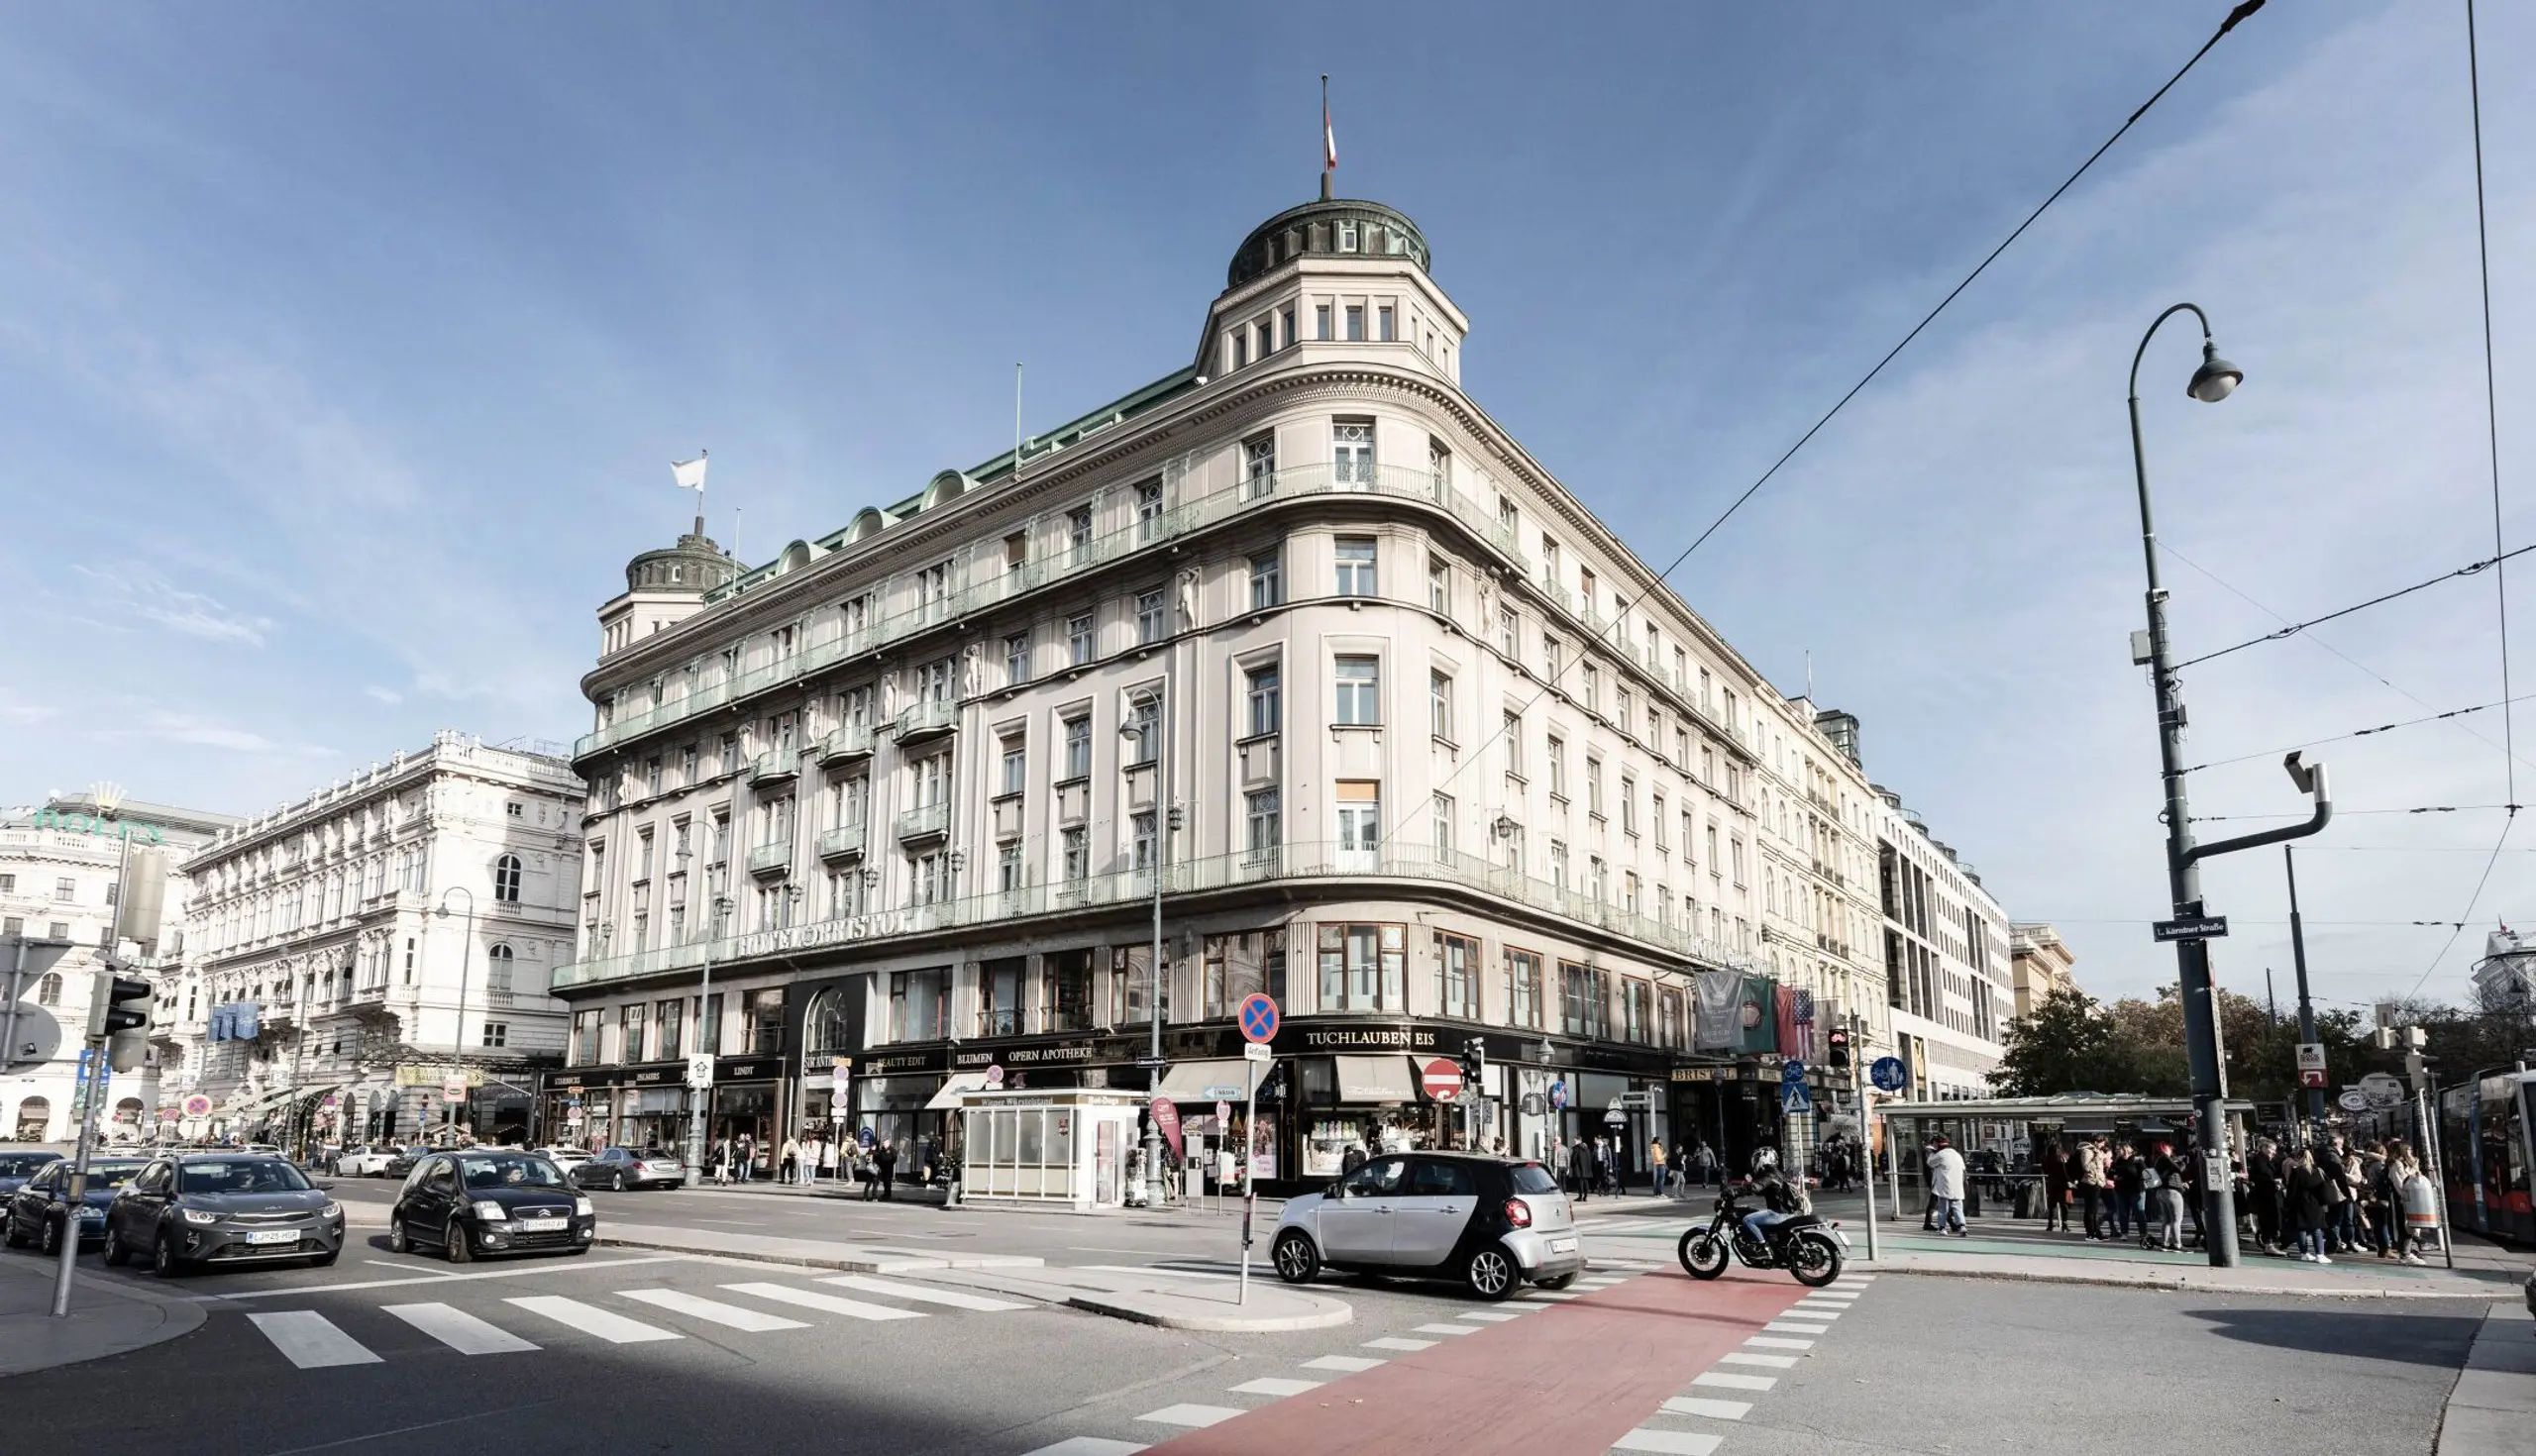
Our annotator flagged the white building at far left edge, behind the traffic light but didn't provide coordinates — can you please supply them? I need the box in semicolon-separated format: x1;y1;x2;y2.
0;791;236;1141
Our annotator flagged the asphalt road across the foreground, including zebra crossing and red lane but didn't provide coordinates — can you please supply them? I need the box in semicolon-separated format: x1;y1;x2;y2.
5;1180;2483;1456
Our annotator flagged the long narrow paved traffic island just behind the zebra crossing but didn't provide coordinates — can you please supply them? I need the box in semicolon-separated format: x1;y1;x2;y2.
598;1222;1354;1334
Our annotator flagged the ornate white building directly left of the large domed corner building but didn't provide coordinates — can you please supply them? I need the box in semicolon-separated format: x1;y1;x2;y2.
170;733;583;1141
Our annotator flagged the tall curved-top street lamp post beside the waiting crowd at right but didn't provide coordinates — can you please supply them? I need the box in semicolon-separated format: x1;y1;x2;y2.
2130;304;2333;1268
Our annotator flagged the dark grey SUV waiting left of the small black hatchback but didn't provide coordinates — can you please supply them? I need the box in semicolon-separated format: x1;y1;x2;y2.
107;1152;343;1279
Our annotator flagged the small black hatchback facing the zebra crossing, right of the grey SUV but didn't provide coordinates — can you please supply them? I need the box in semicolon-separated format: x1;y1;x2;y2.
388;1149;598;1263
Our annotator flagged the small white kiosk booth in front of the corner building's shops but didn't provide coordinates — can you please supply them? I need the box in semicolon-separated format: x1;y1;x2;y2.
959;1089;1144;1212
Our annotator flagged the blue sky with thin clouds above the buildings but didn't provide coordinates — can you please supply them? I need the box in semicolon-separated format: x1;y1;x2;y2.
0;0;2536;1002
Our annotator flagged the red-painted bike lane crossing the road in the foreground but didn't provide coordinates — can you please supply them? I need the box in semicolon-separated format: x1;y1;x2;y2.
1154;1268;1808;1456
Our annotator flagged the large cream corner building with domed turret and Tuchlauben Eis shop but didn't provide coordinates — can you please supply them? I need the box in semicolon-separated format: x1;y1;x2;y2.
545;200;1998;1182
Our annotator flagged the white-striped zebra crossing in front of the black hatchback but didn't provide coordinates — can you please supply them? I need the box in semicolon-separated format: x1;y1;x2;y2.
246;1274;1034;1370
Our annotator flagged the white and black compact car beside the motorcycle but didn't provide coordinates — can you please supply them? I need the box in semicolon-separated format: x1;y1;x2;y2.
1268;1152;1585;1299
